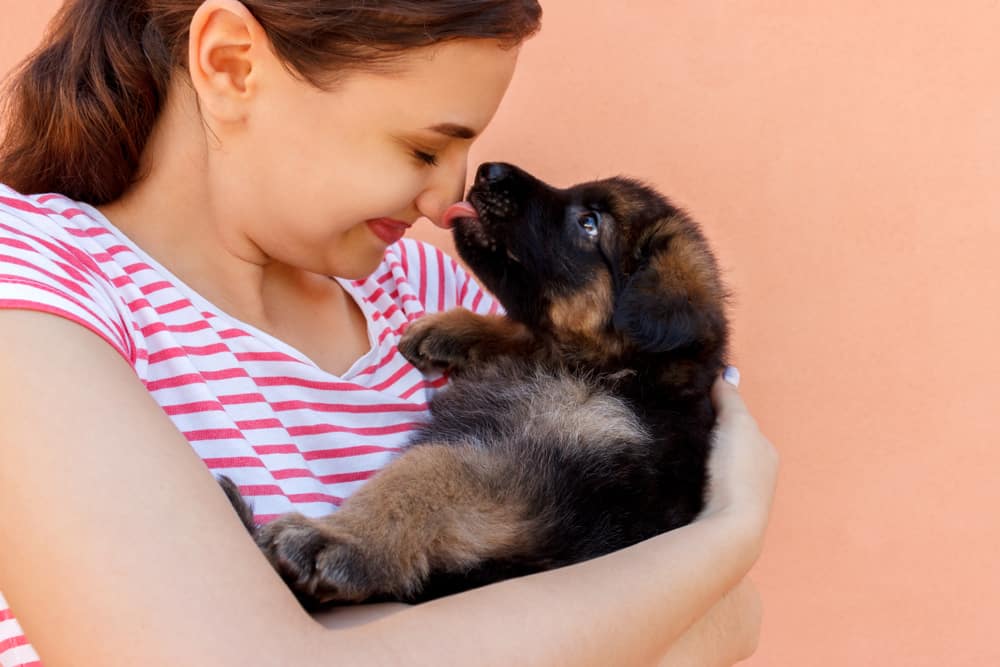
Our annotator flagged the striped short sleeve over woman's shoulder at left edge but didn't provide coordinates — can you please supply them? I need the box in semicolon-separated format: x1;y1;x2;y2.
0;196;135;364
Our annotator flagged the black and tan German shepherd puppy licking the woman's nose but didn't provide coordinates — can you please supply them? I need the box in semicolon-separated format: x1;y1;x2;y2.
222;163;728;605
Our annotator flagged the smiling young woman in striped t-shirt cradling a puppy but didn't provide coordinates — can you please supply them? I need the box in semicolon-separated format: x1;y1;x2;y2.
0;0;776;667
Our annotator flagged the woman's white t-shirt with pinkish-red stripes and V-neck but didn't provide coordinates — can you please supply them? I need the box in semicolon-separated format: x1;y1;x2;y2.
0;186;499;667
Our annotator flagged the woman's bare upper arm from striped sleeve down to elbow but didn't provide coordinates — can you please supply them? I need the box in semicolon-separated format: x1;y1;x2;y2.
0;311;315;667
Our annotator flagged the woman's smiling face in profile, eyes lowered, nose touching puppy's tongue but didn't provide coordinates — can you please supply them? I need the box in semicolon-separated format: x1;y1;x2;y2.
210;40;518;278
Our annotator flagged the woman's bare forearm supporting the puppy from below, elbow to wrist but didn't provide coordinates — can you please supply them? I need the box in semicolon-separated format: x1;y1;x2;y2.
350;508;752;665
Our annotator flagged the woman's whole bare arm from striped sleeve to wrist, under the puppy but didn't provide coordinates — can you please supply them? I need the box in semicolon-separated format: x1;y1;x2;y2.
0;311;776;667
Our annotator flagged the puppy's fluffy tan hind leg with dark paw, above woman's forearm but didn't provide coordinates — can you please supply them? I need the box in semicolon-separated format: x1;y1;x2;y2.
257;445;533;603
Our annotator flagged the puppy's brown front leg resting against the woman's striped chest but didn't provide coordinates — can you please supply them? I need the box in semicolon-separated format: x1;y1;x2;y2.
399;308;537;371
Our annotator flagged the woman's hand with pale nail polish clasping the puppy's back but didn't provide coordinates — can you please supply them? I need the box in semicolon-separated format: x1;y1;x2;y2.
701;368;778;552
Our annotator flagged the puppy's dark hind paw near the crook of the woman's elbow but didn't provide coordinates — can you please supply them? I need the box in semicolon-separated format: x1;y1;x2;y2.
256;514;378;603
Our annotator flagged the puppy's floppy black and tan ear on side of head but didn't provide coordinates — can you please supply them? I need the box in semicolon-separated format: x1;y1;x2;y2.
613;232;727;353
